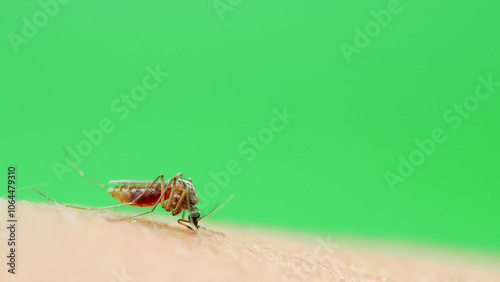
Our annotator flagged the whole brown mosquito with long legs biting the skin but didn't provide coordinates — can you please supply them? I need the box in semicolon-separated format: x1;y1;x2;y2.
31;147;233;235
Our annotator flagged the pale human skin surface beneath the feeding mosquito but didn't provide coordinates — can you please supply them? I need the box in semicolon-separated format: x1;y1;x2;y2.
0;199;500;282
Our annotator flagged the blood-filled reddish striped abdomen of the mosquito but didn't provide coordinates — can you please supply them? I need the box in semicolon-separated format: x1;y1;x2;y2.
108;183;170;207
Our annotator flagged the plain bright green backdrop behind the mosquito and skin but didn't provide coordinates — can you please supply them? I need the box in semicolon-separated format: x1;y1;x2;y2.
0;1;500;252
